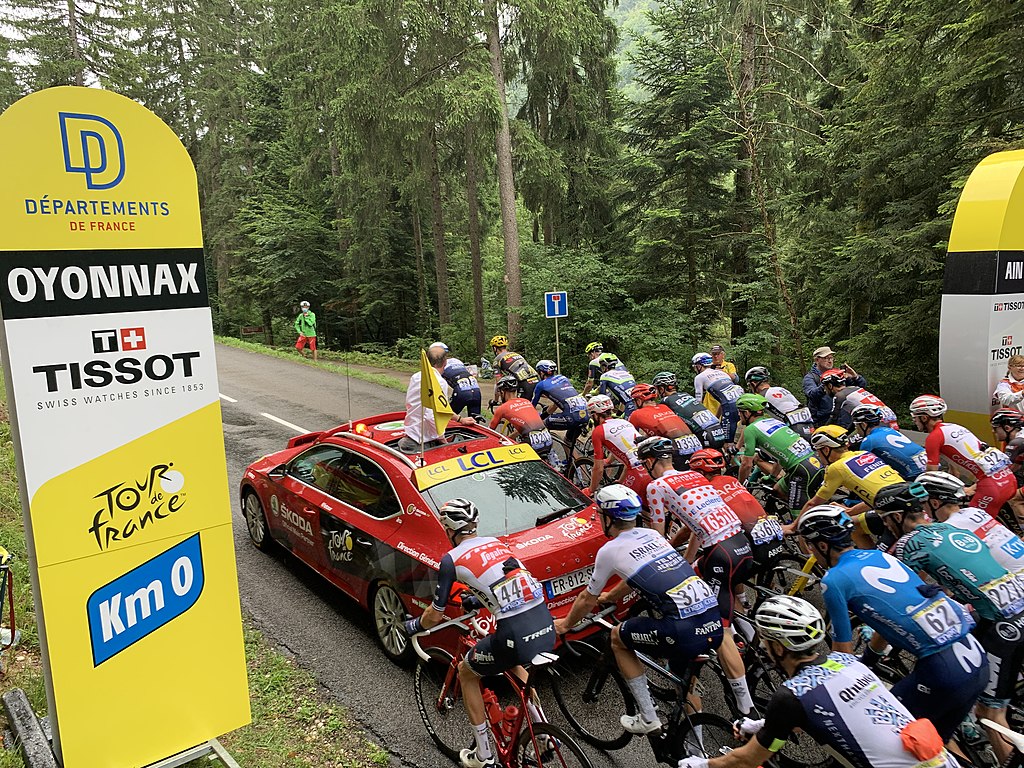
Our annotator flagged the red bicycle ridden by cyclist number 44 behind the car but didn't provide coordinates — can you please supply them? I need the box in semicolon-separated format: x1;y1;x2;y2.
412;611;593;768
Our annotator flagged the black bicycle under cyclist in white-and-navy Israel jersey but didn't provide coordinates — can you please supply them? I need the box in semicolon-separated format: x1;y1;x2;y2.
551;606;739;766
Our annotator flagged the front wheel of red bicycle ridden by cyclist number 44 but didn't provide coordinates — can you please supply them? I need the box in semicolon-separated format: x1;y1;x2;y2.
413;648;470;761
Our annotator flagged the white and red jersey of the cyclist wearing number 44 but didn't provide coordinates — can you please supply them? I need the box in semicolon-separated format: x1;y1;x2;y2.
434;536;545;620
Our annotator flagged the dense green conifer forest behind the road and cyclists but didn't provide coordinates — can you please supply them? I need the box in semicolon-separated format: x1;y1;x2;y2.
0;0;1024;402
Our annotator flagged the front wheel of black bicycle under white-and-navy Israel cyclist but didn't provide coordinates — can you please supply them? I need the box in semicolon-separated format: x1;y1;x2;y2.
551;640;636;750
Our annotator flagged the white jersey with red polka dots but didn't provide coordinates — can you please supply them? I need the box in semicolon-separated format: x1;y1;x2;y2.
647;469;743;549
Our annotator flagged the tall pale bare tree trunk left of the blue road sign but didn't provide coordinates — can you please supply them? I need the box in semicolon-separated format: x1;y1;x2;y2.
484;0;522;346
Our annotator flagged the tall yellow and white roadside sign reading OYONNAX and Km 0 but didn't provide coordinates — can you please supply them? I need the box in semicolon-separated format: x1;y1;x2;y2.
0;87;249;768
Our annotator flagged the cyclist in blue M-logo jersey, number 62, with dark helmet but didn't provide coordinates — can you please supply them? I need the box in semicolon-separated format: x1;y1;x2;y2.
797;504;988;742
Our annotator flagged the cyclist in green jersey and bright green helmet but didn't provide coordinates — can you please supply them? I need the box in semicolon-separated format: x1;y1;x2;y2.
736;394;824;518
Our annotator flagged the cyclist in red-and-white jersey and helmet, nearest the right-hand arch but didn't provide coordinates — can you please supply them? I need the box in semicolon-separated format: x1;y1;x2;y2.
910;394;1017;517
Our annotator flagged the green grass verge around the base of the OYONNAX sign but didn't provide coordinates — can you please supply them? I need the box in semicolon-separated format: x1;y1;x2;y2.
0;378;390;768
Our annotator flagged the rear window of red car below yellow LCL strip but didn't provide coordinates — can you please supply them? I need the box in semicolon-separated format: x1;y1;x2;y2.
423;460;590;536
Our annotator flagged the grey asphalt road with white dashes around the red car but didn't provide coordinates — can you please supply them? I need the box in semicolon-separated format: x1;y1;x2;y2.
217;345;653;768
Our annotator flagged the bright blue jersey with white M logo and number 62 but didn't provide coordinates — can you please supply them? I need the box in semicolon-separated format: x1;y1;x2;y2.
821;549;974;658
